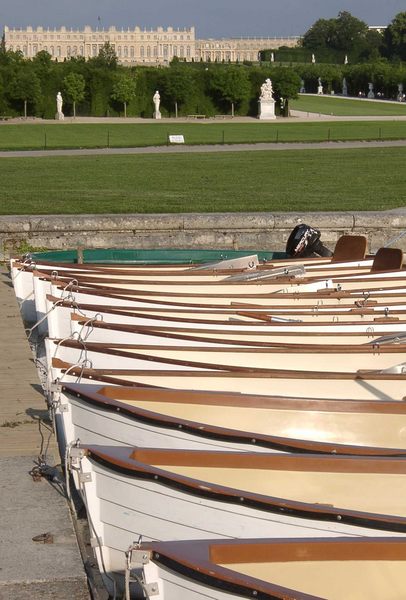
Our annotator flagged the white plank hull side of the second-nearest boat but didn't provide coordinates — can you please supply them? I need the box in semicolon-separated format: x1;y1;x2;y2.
77;450;402;596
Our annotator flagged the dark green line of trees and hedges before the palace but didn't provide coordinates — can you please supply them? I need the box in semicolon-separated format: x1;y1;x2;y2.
0;13;406;119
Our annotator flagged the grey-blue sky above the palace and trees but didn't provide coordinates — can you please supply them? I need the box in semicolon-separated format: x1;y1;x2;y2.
0;0;406;39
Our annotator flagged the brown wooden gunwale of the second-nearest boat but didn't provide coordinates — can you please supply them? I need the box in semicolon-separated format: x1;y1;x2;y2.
78;444;406;533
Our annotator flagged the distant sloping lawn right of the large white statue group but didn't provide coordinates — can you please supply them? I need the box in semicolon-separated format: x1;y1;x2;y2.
290;94;406;117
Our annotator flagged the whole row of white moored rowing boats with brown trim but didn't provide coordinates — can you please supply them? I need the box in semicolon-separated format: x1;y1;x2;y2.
11;236;406;600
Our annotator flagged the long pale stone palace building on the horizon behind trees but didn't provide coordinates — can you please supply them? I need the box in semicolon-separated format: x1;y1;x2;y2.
4;26;299;65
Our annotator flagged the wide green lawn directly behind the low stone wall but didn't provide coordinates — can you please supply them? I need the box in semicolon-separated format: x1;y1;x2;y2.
0;148;406;214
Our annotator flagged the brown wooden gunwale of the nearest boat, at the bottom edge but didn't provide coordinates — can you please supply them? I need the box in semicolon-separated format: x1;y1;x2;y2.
140;537;406;600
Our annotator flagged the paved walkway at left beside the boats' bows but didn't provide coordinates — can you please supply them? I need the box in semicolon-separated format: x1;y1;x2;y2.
0;266;89;600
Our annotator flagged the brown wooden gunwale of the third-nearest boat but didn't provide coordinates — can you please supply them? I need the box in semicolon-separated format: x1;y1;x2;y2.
62;384;406;456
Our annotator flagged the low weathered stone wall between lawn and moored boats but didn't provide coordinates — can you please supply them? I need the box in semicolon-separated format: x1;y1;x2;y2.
0;212;406;257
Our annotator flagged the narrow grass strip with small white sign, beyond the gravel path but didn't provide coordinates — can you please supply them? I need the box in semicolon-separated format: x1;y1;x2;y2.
0;118;406;150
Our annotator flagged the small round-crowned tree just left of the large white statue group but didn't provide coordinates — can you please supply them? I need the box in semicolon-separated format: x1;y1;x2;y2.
210;66;250;116
